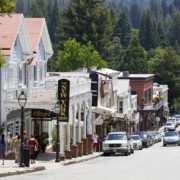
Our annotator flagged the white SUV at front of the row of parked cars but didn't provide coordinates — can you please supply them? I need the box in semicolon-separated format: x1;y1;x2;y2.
103;132;134;156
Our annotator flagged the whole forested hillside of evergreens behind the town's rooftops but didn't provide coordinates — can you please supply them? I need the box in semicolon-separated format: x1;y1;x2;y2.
16;0;180;107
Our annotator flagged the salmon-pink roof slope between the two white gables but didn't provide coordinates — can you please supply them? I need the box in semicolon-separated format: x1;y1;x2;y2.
25;18;45;52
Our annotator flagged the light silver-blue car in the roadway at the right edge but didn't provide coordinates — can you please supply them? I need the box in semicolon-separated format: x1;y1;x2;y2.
163;131;180;146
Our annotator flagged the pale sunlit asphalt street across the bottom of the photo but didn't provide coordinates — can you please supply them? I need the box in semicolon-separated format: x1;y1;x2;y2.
2;139;180;180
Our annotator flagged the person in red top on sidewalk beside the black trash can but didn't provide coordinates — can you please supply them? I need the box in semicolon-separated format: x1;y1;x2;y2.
28;135;38;164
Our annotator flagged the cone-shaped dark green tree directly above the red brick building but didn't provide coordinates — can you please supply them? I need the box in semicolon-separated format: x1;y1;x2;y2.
118;36;148;73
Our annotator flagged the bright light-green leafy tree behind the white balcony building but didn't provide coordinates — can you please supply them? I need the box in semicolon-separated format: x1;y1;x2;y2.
57;39;106;71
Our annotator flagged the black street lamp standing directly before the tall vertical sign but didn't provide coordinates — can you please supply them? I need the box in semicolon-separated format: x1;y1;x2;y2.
54;101;60;162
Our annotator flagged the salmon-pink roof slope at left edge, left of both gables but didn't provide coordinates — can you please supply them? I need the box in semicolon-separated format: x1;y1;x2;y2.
0;14;23;55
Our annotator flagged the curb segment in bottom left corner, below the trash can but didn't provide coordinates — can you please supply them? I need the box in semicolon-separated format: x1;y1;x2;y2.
0;166;46;177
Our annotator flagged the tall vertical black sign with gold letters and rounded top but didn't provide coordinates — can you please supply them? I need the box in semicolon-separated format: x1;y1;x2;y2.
58;79;70;122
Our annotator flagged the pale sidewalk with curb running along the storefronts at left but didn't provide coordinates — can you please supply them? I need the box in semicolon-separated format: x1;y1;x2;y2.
0;152;102;177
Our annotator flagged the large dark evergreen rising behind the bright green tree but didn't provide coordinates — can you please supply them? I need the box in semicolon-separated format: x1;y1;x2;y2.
60;0;112;55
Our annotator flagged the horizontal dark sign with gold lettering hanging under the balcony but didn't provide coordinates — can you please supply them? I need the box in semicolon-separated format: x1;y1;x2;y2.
31;109;53;118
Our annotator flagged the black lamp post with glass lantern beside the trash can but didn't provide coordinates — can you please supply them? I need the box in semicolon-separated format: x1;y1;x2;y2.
18;90;27;167
